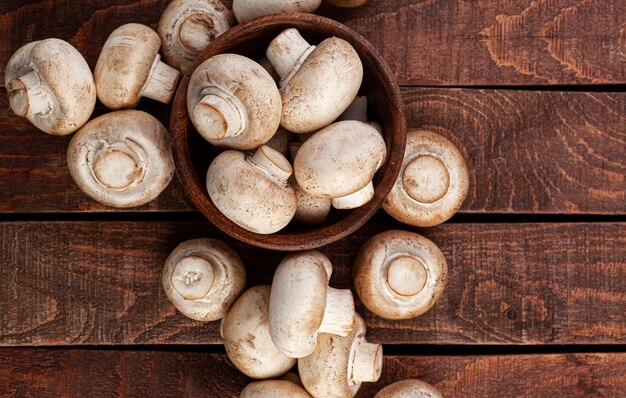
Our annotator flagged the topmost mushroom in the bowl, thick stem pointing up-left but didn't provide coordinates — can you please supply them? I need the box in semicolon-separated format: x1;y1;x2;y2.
266;28;363;134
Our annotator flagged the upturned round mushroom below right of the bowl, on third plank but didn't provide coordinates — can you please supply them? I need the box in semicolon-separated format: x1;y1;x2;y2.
353;230;448;319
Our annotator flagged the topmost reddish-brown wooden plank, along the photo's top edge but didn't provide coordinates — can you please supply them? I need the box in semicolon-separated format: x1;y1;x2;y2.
0;0;626;86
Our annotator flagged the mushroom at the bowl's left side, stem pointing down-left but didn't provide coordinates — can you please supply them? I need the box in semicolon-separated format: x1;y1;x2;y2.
187;54;282;150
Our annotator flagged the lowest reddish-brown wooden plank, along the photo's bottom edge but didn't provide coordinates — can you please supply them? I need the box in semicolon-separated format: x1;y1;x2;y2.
0;349;626;398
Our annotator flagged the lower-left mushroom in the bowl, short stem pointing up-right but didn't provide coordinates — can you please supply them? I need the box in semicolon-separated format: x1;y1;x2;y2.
206;145;297;234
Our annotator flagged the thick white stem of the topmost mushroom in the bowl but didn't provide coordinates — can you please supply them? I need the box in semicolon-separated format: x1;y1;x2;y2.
266;28;315;87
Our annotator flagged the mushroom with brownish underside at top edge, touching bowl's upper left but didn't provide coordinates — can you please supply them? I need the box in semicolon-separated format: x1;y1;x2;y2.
158;0;235;73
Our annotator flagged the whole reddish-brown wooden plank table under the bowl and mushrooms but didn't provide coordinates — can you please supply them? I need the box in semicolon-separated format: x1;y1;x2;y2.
0;0;626;397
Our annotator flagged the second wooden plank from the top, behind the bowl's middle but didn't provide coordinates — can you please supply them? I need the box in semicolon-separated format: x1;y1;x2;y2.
0;88;626;214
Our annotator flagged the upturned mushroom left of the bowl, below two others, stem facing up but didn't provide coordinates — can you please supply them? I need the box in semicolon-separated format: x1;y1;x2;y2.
67;110;174;207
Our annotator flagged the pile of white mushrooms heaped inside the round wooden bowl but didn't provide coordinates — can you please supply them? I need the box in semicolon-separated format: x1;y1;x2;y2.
194;25;387;234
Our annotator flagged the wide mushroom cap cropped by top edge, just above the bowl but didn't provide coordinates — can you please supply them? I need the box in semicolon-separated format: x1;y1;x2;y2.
233;0;322;23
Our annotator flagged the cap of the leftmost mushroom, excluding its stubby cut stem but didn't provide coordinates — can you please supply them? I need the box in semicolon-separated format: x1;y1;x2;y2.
4;39;96;135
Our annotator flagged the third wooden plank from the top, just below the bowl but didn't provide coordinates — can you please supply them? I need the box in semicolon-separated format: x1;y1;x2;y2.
0;221;626;346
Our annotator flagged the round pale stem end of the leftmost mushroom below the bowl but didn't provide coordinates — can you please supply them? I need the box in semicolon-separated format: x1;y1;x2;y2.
171;256;215;300
